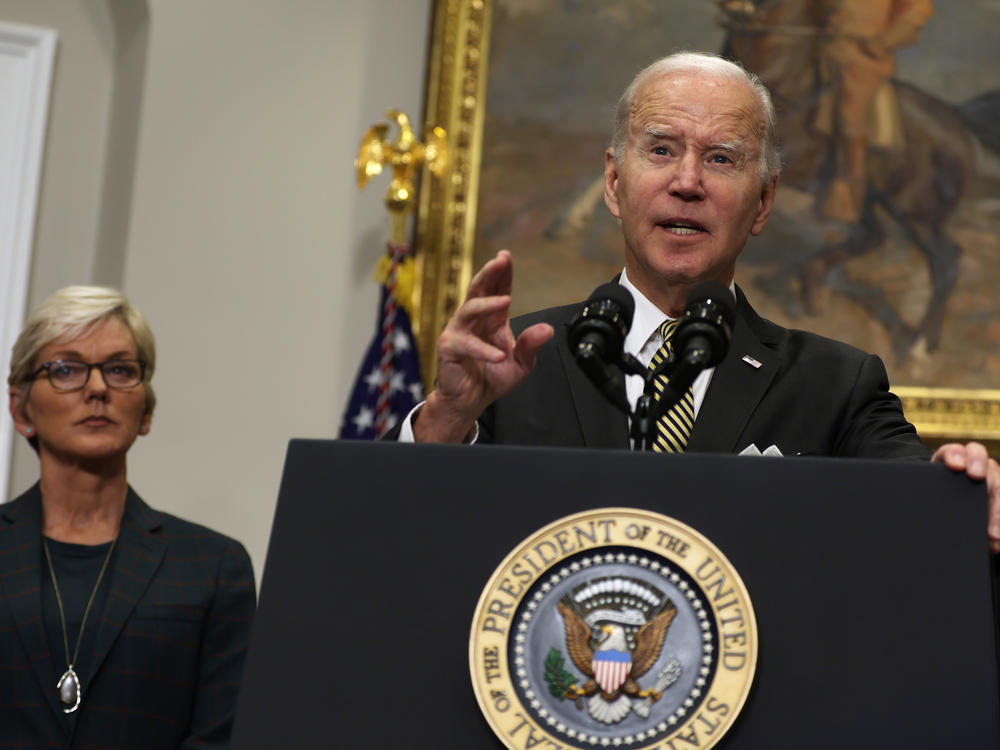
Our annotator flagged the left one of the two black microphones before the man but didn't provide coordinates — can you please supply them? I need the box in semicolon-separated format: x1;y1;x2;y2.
567;282;635;414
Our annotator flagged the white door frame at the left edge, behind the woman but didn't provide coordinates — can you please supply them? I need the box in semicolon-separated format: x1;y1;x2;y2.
0;22;56;502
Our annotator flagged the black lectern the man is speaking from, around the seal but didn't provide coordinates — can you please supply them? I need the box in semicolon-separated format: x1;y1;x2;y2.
233;440;1000;750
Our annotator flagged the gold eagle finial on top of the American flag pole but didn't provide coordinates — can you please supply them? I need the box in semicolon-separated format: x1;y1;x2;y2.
354;109;448;244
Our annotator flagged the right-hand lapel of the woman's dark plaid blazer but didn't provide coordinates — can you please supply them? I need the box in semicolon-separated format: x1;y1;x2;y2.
80;488;167;686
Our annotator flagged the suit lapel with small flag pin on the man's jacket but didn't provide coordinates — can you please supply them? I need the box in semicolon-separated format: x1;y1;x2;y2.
687;295;781;453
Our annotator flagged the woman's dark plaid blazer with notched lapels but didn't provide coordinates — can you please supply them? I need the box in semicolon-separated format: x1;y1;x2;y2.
0;484;256;750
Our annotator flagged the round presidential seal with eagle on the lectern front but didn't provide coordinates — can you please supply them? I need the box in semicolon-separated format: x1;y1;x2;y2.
469;508;757;750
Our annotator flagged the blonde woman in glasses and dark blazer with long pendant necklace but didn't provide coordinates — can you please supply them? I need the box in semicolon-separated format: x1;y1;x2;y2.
0;286;255;750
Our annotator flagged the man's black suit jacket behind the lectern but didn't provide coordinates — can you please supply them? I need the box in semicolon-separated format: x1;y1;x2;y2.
479;289;930;459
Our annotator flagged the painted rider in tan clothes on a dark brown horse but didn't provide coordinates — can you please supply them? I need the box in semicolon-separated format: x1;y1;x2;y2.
718;0;960;362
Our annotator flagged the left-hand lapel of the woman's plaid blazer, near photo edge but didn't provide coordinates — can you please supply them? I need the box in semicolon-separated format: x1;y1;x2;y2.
0;484;68;736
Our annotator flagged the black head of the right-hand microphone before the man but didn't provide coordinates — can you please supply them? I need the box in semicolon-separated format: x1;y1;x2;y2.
674;281;736;370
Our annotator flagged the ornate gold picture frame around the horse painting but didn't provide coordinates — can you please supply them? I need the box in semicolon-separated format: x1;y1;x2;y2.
414;0;1000;453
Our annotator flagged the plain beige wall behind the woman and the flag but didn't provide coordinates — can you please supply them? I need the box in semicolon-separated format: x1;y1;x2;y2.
0;0;431;588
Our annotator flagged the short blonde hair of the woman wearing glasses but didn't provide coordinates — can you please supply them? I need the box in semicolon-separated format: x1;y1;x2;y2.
7;286;156;414
